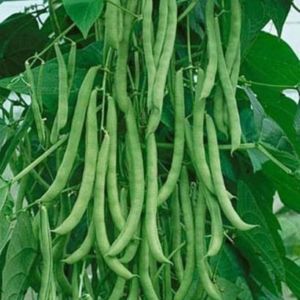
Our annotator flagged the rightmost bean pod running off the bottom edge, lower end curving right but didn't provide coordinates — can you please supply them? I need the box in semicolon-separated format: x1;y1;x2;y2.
195;190;222;300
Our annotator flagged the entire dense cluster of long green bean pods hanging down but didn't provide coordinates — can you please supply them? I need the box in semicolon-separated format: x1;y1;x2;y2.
26;0;255;300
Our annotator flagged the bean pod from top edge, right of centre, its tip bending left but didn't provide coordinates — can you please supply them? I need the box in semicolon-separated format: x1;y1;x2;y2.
200;0;218;99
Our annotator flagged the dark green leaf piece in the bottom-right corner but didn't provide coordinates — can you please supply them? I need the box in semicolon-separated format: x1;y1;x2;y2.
283;258;300;299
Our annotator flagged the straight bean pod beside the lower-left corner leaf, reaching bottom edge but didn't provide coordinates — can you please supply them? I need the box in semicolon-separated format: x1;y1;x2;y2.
39;206;53;300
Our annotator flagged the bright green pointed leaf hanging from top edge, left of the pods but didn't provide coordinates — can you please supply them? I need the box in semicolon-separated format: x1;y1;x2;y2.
63;0;103;38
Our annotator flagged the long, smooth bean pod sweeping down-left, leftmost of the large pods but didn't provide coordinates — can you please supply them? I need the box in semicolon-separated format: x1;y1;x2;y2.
37;67;99;202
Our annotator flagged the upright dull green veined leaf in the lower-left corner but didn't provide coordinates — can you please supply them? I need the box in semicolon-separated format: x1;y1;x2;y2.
2;212;36;300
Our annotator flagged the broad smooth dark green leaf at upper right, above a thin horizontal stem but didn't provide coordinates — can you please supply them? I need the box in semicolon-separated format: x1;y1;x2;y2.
240;32;300;86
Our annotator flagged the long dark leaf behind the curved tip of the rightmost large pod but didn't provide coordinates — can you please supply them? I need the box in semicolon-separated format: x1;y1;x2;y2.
237;181;285;280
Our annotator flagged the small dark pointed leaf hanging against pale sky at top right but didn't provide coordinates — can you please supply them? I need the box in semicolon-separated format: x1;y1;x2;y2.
265;0;291;36
